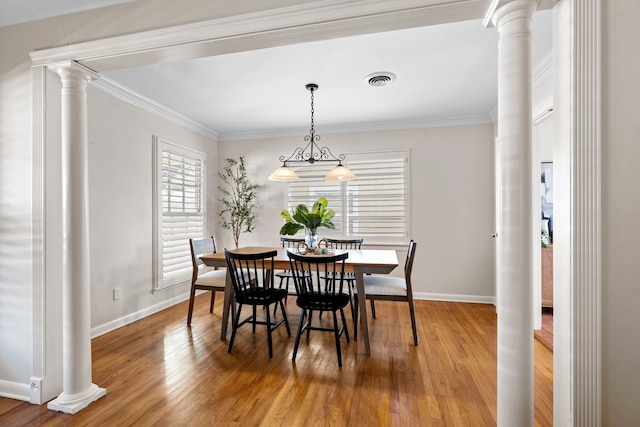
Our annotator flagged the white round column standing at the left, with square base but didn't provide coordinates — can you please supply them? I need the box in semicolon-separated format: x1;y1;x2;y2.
47;61;107;414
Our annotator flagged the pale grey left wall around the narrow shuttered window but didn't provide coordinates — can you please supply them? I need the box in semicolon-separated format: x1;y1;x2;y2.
88;84;217;332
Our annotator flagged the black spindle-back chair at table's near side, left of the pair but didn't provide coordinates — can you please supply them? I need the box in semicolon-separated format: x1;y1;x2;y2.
224;249;291;357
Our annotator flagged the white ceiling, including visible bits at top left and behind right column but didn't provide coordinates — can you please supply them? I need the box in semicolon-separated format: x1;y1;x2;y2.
0;0;552;140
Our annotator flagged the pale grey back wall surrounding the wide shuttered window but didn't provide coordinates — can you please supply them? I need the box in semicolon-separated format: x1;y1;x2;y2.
218;125;494;302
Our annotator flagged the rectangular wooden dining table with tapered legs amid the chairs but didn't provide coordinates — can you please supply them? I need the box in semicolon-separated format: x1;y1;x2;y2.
200;246;398;356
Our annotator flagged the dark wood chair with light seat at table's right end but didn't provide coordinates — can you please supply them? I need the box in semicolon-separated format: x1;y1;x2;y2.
353;240;418;345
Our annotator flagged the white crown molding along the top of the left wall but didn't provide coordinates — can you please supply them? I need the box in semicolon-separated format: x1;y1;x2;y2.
90;77;219;141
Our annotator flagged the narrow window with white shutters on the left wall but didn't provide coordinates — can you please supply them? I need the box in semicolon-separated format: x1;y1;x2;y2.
154;137;206;289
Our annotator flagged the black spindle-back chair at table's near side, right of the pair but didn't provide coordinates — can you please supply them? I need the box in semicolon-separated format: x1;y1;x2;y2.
289;252;349;366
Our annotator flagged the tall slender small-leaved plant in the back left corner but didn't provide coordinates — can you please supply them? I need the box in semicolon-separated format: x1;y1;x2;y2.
218;156;260;248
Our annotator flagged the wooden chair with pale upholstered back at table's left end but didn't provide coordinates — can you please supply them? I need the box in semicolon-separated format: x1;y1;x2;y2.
187;236;227;326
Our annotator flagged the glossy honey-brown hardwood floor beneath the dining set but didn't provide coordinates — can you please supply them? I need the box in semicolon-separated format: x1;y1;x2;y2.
0;295;553;426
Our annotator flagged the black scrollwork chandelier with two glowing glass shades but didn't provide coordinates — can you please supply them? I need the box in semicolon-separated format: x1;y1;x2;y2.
269;83;356;182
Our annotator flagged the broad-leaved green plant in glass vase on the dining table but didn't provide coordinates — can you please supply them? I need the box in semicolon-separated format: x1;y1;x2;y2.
280;197;336;248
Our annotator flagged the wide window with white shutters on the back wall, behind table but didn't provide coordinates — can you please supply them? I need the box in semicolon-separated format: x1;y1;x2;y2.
288;150;409;245
